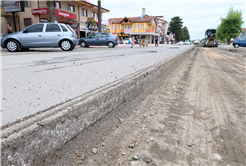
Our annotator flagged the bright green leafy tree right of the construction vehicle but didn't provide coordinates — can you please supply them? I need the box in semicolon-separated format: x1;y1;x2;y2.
216;7;244;43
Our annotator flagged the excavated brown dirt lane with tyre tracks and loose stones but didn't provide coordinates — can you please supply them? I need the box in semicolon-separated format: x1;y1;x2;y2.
35;47;246;166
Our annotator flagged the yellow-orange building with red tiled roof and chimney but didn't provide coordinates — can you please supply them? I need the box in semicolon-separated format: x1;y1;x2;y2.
108;8;160;43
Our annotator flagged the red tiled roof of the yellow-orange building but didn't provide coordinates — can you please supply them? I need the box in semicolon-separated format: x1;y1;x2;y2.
108;15;155;24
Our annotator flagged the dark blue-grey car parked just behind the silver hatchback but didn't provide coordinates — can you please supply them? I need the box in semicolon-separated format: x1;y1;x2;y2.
79;33;118;48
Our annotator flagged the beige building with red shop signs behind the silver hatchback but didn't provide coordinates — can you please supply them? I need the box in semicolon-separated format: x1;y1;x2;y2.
0;0;109;37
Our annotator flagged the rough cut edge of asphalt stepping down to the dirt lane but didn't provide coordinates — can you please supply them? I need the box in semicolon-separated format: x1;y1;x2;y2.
0;48;194;165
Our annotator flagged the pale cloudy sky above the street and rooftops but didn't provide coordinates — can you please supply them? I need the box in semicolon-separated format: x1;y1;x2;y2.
89;0;246;40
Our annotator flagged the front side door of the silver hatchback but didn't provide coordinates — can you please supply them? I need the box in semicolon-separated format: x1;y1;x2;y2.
19;24;44;48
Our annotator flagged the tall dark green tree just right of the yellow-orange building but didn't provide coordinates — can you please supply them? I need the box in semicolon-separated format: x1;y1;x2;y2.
168;16;183;42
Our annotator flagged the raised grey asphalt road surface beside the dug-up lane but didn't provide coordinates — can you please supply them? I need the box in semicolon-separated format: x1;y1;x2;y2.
0;45;193;126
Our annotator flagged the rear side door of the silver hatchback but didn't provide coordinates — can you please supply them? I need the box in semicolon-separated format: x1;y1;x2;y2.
44;23;63;47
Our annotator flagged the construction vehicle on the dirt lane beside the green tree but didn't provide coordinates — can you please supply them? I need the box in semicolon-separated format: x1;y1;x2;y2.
202;29;218;47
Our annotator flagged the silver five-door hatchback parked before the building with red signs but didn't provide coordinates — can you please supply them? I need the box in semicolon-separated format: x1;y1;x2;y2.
0;23;78;52
